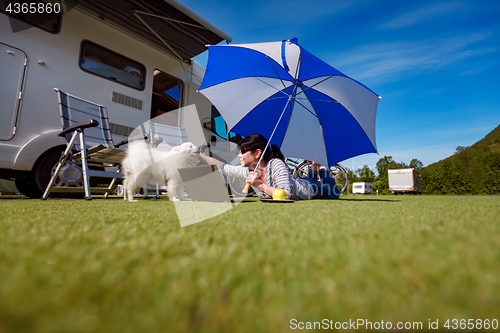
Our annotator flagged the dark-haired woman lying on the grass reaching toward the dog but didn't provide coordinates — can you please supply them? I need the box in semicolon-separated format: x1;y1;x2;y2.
200;134;340;200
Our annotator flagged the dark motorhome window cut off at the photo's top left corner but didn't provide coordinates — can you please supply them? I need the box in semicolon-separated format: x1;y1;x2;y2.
0;0;62;34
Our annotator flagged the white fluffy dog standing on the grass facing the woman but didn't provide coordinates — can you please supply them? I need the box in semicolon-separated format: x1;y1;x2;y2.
122;141;198;202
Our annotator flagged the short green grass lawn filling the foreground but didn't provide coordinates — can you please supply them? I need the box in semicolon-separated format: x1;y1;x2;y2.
0;196;500;333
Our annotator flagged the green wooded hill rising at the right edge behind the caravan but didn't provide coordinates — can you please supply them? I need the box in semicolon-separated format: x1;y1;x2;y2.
421;125;500;194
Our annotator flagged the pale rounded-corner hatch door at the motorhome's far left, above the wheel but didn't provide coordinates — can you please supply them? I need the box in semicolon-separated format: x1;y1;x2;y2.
0;43;28;141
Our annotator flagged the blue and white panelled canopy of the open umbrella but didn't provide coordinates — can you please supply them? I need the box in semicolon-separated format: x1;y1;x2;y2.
199;39;380;166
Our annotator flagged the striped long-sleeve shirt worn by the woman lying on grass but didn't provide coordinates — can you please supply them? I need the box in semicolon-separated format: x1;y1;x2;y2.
219;158;314;200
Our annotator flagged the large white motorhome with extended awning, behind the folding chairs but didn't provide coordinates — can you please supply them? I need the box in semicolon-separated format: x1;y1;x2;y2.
0;0;231;198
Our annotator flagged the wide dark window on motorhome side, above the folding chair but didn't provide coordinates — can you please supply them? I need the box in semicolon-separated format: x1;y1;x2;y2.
80;41;146;90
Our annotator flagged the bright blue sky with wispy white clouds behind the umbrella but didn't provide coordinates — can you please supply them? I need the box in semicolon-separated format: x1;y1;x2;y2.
181;0;500;169
